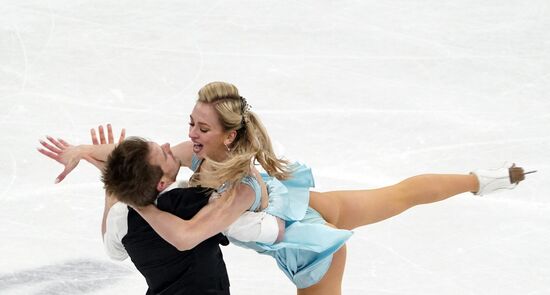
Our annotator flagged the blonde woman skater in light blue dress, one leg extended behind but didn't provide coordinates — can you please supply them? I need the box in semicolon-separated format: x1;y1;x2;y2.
38;82;524;294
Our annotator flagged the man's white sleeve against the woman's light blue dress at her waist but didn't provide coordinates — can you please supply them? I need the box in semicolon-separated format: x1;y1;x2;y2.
223;211;279;244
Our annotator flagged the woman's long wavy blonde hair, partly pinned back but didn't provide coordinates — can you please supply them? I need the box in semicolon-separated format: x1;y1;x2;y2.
197;82;290;187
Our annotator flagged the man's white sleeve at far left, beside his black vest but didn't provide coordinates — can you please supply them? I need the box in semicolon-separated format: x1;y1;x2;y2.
103;202;128;260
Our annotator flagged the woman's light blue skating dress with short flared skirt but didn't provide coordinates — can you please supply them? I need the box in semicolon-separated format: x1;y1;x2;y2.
191;155;352;289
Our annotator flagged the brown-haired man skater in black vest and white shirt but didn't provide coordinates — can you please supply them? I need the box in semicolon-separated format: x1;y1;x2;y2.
41;126;284;295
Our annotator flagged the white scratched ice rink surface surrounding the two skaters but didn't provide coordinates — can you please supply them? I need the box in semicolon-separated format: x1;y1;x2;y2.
0;0;550;295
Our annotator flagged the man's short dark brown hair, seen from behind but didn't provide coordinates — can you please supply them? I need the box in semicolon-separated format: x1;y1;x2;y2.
101;137;163;207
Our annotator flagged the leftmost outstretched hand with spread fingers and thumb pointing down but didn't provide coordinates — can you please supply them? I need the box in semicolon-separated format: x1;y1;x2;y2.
38;136;83;183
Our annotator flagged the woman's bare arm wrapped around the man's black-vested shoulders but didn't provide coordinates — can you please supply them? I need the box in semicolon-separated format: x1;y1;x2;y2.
136;184;255;251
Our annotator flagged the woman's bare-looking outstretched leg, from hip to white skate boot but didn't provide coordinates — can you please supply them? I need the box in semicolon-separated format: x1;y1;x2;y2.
310;174;479;229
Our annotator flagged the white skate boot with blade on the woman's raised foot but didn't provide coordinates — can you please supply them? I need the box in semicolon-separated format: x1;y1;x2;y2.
471;164;536;196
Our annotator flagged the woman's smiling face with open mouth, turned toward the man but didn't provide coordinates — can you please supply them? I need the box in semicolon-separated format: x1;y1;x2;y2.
189;102;229;161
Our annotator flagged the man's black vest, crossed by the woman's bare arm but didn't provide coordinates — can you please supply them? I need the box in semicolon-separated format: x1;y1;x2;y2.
122;188;229;295
